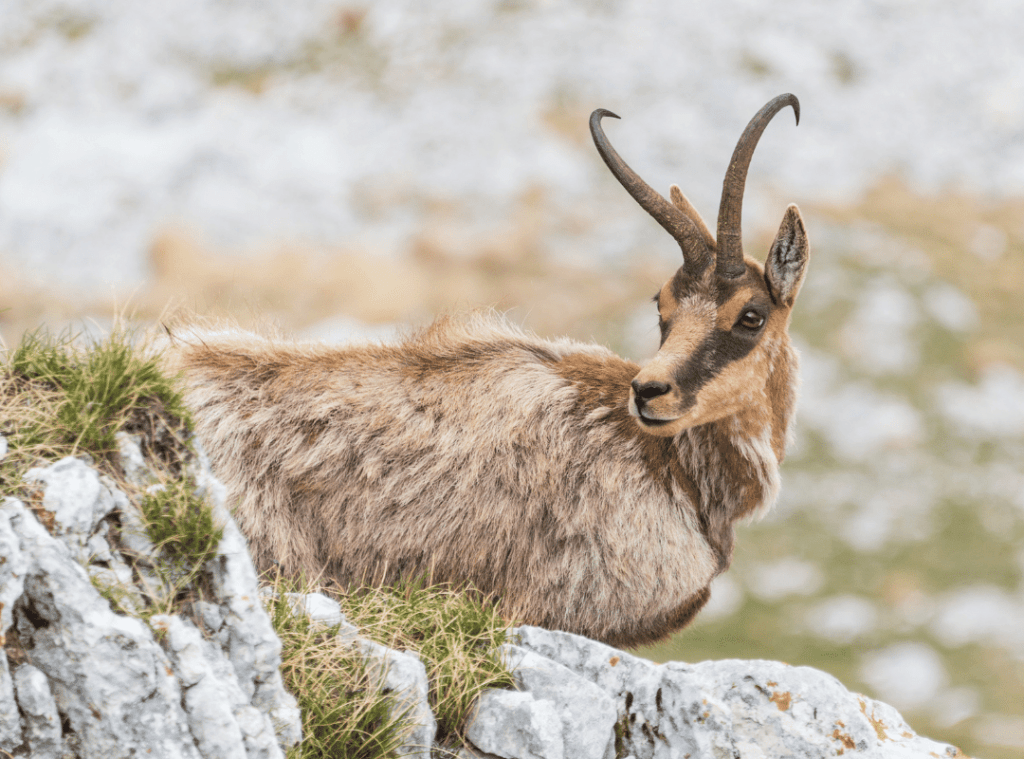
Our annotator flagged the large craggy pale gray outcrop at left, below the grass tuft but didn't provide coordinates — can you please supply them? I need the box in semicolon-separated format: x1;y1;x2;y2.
0;437;301;759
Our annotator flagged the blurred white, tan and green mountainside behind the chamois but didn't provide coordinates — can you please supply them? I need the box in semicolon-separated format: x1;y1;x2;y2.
0;0;1024;759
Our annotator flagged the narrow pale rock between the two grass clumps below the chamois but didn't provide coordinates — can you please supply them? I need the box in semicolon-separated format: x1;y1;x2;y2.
360;631;437;759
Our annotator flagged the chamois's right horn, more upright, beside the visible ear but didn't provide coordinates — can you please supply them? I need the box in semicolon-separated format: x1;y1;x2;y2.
715;94;800;277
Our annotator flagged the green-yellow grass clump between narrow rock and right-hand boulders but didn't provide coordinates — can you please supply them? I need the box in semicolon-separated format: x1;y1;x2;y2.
338;582;515;746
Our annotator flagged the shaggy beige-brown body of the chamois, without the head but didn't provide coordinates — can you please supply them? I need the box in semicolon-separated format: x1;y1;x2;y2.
166;290;787;645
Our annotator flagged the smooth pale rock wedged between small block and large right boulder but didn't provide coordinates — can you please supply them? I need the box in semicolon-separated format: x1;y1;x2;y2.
502;644;617;759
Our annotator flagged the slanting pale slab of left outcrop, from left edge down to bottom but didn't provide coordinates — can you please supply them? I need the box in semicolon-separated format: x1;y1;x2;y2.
2;499;199;759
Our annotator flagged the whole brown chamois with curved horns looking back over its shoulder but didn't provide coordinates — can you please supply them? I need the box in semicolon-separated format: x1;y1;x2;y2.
168;95;809;646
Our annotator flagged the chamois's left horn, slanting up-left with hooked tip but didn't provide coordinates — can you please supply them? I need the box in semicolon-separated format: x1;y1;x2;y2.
590;109;712;272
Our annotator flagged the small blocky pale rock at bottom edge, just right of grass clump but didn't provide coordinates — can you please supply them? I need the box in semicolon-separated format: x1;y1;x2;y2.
466;689;565;759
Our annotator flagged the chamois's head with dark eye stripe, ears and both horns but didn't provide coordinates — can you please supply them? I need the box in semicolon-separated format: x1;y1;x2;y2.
590;94;810;436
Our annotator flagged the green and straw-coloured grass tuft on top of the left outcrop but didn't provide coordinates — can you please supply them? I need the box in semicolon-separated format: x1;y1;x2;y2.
0;323;190;486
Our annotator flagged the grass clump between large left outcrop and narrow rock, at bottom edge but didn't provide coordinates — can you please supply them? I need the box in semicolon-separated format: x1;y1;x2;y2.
267;582;410;759
